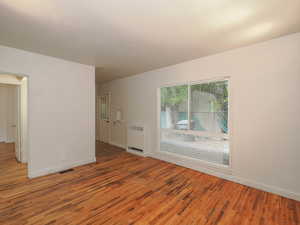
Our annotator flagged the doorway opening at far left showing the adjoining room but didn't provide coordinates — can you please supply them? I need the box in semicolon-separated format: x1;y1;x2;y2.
0;74;29;176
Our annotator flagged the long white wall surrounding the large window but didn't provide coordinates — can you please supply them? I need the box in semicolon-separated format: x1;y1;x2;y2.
99;33;300;200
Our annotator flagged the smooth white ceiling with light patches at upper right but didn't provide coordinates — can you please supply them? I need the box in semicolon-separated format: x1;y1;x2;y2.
0;0;300;82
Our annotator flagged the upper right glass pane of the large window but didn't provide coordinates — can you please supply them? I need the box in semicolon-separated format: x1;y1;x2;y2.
191;81;228;134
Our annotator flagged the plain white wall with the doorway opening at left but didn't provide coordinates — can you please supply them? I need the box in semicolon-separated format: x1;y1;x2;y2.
0;46;95;177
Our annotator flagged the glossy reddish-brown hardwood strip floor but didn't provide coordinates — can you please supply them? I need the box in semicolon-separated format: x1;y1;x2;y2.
0;143;300;225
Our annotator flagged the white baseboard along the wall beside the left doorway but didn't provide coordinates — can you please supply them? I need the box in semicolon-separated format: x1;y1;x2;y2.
28;157;96;178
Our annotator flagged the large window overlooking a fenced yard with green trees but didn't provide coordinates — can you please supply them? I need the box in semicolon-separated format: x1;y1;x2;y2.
160;80;229;165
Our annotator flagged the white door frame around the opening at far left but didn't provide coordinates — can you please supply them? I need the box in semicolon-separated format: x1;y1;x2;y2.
0;74;31;169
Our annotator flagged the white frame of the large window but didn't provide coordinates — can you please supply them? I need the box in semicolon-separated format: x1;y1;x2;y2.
157;76;234;171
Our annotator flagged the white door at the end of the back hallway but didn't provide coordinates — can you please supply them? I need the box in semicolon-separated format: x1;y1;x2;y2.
97;94;110;143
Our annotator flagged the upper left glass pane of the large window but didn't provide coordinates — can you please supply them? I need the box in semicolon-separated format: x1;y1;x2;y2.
160;85;188;129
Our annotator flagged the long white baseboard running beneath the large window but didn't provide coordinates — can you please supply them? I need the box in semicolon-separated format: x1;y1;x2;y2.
148;153;300;201
